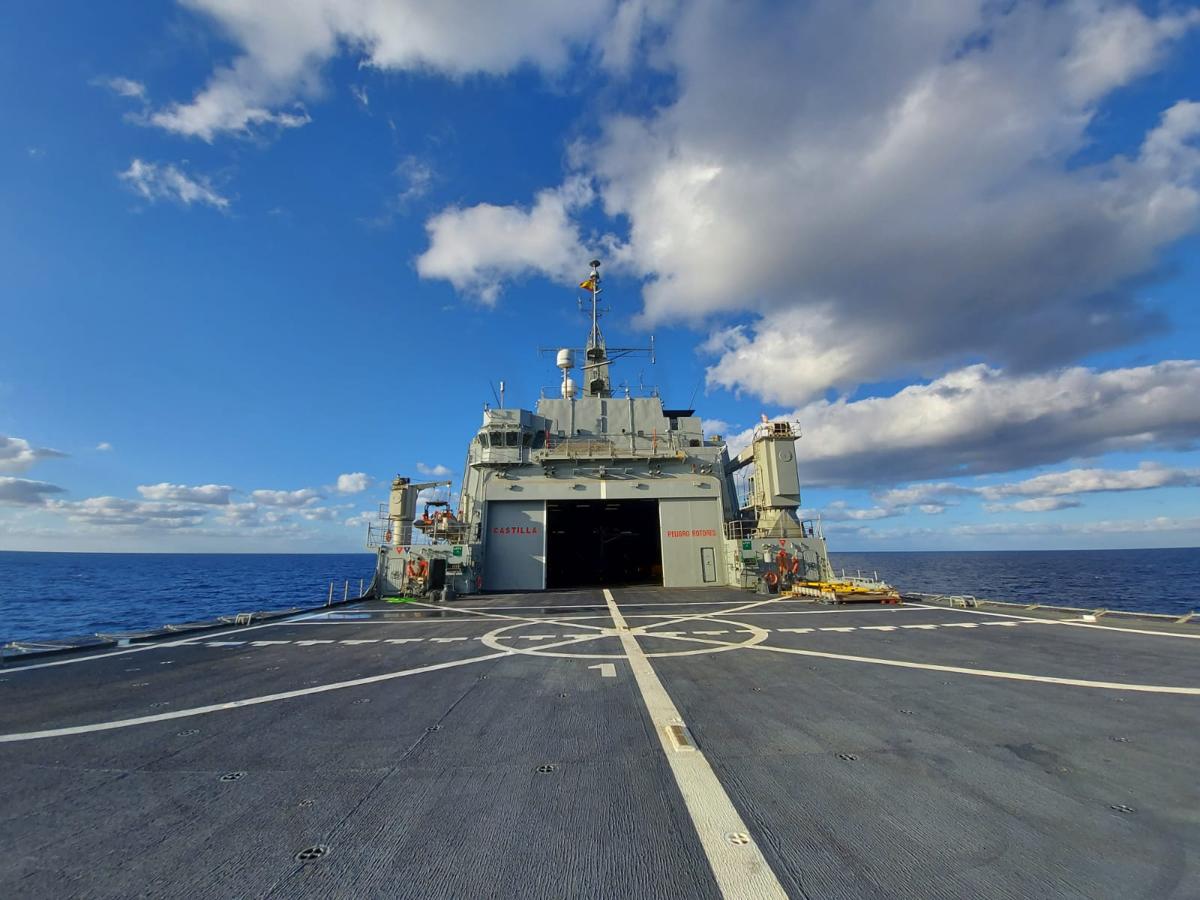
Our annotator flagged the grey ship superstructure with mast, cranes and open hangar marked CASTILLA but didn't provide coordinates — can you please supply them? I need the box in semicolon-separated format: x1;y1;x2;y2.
368;260;832;599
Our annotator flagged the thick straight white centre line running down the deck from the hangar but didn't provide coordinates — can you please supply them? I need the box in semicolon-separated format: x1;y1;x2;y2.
604;589;787;900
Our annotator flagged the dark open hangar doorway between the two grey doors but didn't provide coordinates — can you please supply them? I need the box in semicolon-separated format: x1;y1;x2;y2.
546;500;662;588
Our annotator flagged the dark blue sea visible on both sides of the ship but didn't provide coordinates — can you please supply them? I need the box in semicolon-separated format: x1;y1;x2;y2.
0;548;1200;644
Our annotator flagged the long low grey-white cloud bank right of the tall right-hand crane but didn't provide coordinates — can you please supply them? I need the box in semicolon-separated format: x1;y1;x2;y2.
730;360;1200;489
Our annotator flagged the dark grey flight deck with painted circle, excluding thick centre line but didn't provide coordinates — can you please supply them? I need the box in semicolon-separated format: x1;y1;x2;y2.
0;589;1200;899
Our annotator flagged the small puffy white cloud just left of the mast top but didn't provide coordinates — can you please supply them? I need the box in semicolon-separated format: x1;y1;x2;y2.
416;178;594;304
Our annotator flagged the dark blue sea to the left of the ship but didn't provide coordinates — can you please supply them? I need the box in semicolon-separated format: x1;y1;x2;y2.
0;551;374;644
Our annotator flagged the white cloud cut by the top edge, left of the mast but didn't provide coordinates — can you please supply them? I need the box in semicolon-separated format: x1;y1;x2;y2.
149;0;610;142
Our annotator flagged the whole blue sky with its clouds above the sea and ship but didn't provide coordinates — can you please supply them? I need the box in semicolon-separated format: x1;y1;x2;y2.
0;0;1200;552
